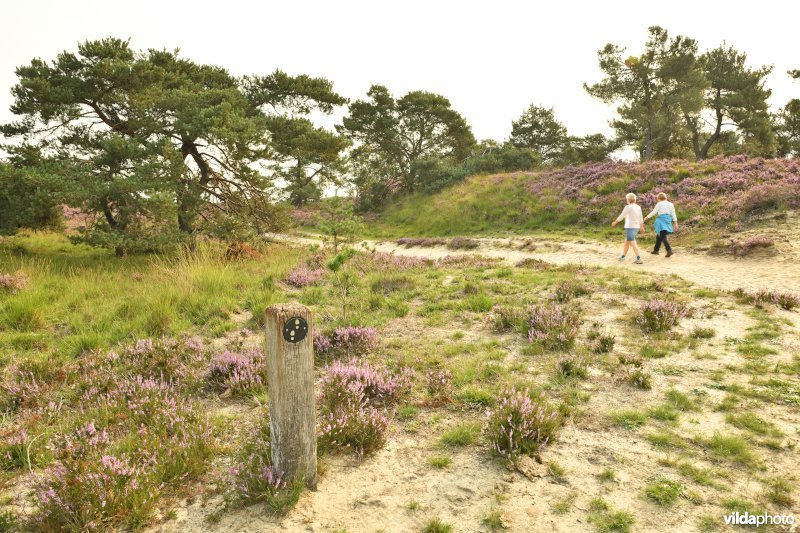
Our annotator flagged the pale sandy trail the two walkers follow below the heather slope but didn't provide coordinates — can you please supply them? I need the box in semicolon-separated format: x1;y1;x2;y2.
273;233;800;292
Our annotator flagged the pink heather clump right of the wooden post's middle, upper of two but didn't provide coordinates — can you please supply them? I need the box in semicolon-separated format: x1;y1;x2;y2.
319;359;413;410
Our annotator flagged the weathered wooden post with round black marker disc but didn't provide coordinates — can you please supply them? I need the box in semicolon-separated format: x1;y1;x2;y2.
266;303;317;489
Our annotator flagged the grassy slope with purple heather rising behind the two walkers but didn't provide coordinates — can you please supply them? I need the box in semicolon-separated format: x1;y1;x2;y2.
371;155;800;236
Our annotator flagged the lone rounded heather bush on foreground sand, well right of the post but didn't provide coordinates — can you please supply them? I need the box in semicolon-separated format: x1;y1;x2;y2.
486;390;563;460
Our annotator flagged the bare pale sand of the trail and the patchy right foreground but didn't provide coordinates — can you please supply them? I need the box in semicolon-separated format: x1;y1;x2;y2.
150;233;800;533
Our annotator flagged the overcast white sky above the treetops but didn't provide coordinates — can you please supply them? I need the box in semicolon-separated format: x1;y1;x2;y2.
0;0;800;140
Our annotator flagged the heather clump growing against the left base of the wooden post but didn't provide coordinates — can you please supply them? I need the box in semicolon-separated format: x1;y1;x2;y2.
230;414;303;514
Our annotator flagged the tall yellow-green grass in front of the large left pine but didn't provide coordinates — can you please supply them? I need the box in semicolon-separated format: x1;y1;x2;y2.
0;233;303;357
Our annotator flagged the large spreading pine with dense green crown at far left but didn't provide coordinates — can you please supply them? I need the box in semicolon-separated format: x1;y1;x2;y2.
4;38;345;251
